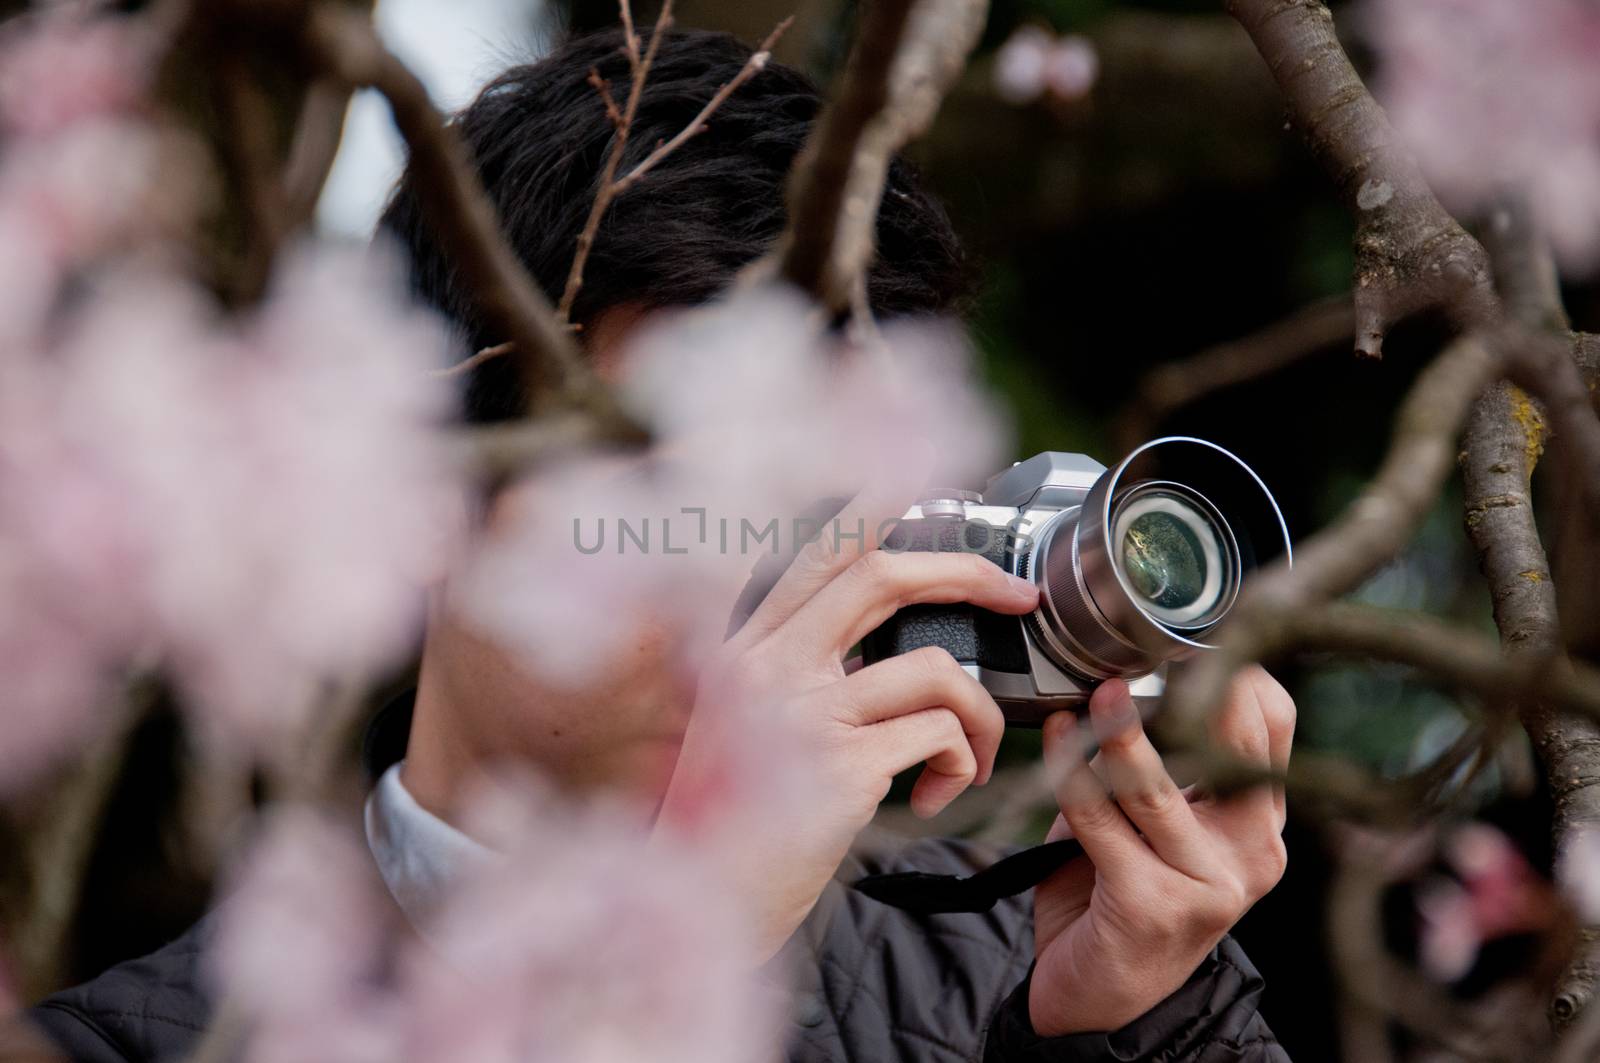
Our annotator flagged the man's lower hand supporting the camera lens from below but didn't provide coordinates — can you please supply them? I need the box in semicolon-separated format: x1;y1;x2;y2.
1029;668;1294;1037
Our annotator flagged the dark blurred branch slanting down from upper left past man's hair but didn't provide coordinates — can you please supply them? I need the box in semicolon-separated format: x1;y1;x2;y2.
307;5;620;434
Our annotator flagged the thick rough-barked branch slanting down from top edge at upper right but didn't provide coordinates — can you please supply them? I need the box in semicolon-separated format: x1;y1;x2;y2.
1229;0;1496;357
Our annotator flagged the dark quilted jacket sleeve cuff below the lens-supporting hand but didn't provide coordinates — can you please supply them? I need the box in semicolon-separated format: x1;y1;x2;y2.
984;938;1290;1063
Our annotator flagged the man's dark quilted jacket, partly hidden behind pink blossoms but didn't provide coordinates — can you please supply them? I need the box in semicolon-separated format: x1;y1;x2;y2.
30;706;1288;1063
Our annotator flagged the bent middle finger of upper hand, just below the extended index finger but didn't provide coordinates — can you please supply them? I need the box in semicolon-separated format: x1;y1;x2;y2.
818;647;1005;784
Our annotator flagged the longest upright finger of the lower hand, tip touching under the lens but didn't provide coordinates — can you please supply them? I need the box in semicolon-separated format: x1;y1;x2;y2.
1090;679;1216;879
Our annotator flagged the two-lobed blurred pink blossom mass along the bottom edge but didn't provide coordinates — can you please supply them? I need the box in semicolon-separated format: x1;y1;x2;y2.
213;789;781;1063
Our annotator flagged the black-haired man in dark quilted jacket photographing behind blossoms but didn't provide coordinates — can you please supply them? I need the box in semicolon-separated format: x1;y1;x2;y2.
34;24;1294;1063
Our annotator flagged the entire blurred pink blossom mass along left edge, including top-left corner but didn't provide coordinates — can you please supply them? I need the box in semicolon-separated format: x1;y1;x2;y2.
0;12;464;789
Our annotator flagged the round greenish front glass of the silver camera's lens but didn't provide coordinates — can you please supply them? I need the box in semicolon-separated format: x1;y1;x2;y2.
1114;490;1232;628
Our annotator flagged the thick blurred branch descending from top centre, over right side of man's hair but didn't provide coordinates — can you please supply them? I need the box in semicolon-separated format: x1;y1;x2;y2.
771;0;989;314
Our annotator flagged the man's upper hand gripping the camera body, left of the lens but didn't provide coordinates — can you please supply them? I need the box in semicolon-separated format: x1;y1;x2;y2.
658;480;1038;959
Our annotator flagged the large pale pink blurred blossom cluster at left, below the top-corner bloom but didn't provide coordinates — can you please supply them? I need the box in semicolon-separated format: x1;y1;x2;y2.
0;250;461;784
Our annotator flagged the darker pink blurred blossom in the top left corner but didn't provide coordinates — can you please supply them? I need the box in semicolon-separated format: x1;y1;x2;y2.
0;11;150;136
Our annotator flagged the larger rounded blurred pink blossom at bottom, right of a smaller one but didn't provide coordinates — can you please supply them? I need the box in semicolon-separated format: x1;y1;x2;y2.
405;781;779;1063
